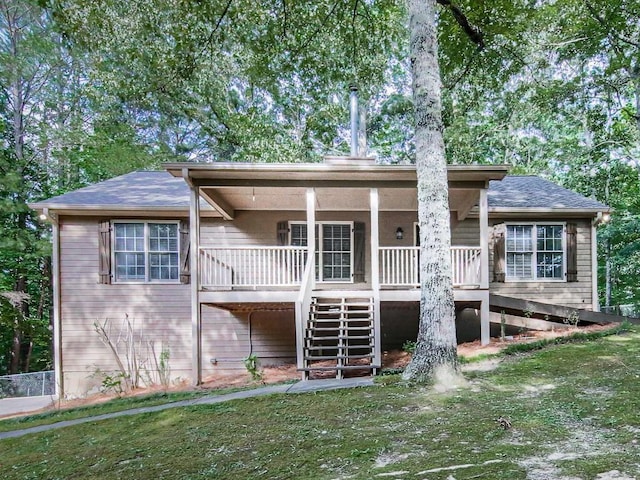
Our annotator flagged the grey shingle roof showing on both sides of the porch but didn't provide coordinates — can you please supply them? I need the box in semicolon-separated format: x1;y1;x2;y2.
32;171;608;210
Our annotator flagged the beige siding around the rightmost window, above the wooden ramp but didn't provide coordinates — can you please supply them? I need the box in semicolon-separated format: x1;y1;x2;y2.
489;219;592;309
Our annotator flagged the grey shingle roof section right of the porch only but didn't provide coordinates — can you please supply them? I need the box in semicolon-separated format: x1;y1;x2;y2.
487;175;608;210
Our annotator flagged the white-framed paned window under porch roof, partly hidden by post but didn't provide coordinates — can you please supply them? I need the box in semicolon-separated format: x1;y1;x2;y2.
289;222;353;282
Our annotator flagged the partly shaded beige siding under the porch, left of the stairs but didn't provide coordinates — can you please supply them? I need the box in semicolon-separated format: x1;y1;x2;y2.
202;305;296;380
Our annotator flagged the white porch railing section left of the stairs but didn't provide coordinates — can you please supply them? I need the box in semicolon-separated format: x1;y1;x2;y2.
200;246;307;288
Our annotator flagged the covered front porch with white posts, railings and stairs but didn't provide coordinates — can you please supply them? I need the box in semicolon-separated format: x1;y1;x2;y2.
168;163;506;378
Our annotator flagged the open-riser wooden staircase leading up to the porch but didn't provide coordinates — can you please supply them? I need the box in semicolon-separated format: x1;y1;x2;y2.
302;297;378;380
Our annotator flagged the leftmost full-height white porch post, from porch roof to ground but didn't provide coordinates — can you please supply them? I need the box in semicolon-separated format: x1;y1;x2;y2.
182;169;202;385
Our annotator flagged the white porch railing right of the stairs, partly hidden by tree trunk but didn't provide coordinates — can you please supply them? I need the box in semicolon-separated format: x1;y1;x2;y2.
380;247;480;287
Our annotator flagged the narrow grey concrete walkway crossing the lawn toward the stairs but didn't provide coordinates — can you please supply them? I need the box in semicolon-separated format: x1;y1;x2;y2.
0;377;373;440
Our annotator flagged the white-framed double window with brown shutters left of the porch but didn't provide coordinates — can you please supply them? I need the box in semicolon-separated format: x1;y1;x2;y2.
113;222;180;282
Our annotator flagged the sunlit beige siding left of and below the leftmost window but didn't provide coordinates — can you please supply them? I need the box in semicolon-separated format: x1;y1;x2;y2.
60;217;191;396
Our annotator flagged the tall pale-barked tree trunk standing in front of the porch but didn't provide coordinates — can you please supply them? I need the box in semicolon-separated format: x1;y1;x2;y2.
404;0;457;381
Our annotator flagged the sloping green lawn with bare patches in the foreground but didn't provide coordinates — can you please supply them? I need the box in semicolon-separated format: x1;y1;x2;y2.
0;328;640;480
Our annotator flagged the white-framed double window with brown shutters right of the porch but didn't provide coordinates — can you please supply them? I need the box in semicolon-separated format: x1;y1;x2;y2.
506;224;565;280
